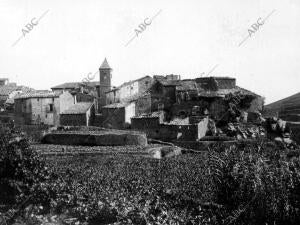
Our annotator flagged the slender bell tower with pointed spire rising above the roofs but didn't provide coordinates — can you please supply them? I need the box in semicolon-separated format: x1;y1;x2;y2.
98;58;112;110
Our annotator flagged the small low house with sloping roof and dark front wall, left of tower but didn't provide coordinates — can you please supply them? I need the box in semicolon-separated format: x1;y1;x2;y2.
60;102;95;126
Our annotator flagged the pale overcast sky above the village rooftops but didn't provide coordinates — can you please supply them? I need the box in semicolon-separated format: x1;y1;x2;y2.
0;0;300;103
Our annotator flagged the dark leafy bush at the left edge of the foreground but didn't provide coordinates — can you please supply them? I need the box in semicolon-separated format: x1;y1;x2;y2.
0;125;50;211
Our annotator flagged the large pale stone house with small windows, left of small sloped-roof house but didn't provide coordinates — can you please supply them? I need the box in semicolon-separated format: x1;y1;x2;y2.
15;91;75;126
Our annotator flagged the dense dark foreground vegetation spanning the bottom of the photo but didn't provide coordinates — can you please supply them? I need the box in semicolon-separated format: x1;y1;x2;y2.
0;125;300;224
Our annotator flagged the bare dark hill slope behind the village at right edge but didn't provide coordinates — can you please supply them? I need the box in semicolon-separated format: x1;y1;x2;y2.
264;92;300;122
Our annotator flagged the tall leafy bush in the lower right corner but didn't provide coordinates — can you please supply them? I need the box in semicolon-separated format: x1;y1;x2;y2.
208;142;300;225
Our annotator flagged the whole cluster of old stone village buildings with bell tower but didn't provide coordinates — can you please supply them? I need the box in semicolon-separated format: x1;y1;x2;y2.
0;58;296;148
